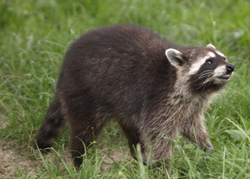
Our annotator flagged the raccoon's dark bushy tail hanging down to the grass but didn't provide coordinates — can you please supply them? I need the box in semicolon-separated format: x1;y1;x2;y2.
35;95;66;152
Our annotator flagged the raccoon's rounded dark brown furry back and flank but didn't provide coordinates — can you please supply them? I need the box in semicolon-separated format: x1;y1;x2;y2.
58;26;176;117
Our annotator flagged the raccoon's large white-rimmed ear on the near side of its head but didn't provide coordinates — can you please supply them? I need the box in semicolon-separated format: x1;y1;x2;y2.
165;48;184;68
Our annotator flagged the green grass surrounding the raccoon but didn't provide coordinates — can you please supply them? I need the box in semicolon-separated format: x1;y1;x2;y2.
0;0;250;178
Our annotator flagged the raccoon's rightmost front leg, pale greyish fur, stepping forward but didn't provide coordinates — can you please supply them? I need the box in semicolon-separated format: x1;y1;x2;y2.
182;118;214;153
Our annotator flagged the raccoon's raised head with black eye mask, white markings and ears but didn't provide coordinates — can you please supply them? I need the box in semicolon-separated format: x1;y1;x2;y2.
165;44;234;92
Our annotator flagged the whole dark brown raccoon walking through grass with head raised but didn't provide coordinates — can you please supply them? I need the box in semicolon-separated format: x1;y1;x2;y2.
36;25;234;168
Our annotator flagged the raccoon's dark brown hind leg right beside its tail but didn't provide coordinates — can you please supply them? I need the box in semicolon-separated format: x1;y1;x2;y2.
67;103;107;168
